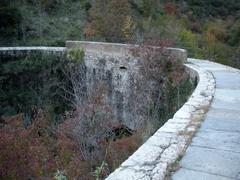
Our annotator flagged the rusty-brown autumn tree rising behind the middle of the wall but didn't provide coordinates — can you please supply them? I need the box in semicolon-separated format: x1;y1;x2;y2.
84;0;134;42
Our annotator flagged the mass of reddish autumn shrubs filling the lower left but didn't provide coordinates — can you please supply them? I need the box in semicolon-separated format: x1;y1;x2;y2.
0;108;142;179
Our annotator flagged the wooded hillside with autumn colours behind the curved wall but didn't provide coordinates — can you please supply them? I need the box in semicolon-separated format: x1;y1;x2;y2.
0;0;240;67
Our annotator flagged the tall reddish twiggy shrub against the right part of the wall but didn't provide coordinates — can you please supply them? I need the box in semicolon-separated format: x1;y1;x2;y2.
132;40;186;129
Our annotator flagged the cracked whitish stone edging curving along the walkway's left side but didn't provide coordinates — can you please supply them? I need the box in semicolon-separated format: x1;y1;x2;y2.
106;60;216;180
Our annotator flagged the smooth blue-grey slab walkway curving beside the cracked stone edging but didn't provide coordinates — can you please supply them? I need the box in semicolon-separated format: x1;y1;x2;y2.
172;59;240;180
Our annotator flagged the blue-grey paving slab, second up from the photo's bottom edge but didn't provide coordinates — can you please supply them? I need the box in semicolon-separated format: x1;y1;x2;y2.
175;146;240;180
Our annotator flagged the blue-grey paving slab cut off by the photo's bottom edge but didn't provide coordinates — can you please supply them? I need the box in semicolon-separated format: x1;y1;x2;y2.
172;168;234;180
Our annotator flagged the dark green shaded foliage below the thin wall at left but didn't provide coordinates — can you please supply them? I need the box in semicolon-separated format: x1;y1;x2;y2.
0;52;69;124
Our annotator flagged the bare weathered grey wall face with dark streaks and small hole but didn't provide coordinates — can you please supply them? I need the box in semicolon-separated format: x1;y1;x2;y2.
66;41;143;130
